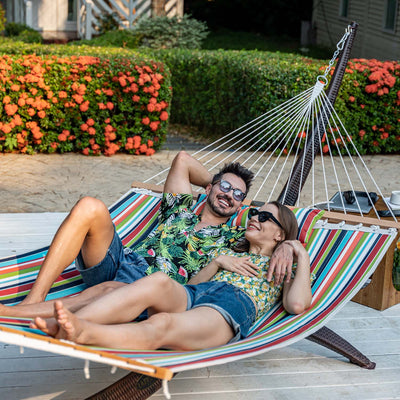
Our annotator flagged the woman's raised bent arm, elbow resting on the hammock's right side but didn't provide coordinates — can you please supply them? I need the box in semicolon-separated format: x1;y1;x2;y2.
283;240;311;314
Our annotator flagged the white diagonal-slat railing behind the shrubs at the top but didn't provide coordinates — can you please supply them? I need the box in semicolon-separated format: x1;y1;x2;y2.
77;0;184;40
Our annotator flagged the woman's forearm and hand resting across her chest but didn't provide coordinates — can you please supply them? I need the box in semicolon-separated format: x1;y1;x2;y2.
188;254;258;285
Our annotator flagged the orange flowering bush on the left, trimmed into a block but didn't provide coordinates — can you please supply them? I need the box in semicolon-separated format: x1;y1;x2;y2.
0;55;171;156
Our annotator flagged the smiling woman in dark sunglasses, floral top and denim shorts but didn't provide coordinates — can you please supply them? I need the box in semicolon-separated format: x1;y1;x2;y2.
31;202;311;350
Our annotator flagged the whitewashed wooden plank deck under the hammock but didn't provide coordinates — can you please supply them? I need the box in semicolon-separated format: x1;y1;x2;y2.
0;213;400;400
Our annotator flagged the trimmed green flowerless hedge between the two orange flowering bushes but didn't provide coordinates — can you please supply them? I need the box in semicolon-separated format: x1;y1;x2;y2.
152;50;319;134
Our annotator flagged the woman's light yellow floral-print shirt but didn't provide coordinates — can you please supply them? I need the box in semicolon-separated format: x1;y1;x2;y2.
208;249;308;318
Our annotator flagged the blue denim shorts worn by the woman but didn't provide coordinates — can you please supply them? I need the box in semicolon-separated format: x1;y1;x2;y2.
184;281;257;343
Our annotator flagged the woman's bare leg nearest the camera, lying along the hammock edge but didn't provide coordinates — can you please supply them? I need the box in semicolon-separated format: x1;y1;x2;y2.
39;301;233;350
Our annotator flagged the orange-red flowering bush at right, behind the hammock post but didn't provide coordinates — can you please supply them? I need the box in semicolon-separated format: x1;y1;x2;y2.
320;59;400;154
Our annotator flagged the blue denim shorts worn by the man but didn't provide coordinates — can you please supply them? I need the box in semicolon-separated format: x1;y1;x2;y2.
75;227;149;286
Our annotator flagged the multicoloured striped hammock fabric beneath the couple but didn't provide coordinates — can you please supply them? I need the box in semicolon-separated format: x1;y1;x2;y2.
0;192;396;372
